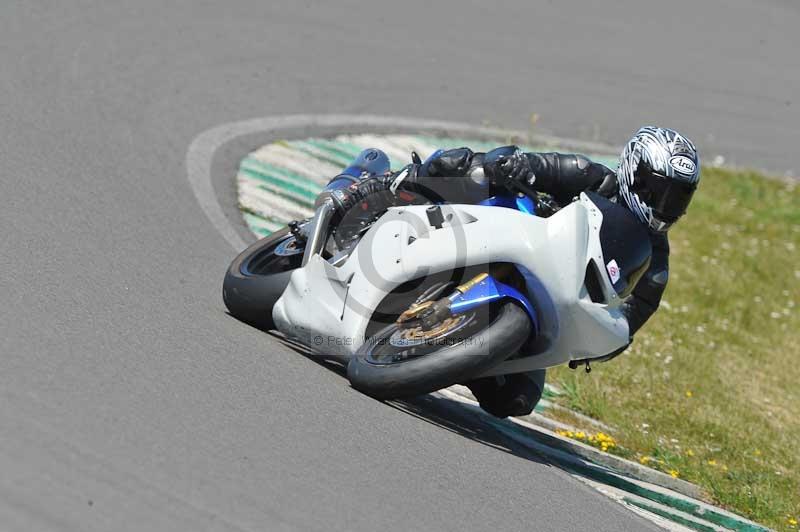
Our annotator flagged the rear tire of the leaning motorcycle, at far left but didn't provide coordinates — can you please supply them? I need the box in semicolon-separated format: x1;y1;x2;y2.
222;228;303;329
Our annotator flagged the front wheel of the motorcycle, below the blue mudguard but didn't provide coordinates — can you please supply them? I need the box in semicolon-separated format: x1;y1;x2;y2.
347;301;531;399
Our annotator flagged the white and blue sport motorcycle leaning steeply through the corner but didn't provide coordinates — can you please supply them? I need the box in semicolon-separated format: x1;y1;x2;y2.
223;150;652;399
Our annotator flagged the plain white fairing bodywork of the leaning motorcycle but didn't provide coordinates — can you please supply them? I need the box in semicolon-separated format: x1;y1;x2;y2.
272;194;628;375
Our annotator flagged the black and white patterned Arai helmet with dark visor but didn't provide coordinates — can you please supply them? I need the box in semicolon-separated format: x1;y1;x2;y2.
617;126;700;232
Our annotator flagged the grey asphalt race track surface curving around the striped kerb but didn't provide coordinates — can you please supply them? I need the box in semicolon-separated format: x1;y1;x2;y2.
0;0;800;531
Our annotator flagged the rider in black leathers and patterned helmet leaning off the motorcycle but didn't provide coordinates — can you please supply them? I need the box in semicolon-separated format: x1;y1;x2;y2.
331;126;700;417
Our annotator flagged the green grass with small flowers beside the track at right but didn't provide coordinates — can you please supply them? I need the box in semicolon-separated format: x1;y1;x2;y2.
548;168;800;530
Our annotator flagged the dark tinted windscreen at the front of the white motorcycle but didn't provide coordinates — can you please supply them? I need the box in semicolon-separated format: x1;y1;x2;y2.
587;192;653;299
